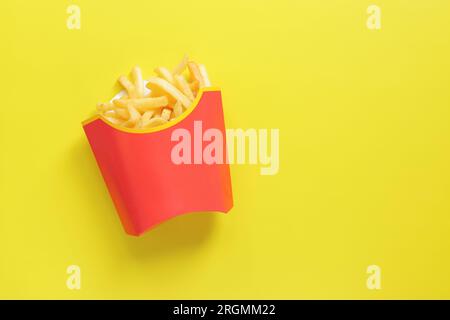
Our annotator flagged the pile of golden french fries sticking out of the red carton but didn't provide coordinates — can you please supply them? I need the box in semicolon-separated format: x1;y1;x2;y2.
97;56;211;129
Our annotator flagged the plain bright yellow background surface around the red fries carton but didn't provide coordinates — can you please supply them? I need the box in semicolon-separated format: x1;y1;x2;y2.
0;0;450;299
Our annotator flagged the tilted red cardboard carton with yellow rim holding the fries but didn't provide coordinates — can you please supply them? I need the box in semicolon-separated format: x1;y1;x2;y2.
83;88;233;235
